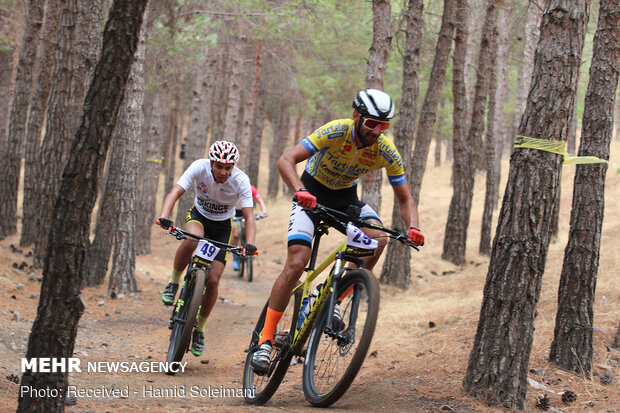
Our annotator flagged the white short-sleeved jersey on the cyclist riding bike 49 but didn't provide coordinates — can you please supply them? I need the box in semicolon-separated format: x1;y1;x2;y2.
177;159;253;221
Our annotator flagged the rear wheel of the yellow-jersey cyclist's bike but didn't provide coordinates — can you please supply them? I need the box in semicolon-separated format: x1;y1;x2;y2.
243;291;301;405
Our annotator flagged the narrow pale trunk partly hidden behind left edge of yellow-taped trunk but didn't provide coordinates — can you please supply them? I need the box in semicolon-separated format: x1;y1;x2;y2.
503;0;546;153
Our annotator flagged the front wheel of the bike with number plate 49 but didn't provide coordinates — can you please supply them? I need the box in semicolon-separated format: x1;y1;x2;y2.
166;269;207;375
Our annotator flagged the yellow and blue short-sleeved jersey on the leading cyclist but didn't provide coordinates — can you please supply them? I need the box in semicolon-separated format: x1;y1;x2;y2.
301;119;407;189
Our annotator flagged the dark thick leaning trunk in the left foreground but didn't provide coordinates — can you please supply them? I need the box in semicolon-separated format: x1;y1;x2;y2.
17;0;147;413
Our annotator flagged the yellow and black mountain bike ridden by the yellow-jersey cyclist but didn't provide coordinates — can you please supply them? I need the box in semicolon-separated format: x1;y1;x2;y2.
243;204;418;407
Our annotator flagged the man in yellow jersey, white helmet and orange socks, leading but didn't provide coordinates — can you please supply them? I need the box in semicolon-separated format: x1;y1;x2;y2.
252;89;424;373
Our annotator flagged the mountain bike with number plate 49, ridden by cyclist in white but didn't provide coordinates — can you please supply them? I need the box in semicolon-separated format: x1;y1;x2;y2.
158;222;251;375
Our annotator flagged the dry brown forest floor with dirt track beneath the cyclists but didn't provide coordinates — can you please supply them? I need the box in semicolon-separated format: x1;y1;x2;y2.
0;142;620;413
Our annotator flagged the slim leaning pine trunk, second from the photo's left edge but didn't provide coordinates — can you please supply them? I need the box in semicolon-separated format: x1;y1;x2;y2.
19;0;60;246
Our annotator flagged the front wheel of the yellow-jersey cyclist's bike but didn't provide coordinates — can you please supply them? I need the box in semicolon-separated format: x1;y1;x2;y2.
303;269;379;407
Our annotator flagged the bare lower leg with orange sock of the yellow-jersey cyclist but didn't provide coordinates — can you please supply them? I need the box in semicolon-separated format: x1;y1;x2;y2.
258;245;311;345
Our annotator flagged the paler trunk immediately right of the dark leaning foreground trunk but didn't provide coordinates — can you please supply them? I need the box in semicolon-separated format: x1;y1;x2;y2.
108;11;148;297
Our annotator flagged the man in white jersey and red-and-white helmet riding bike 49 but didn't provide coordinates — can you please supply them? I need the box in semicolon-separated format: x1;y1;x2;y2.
159;141;256;356
